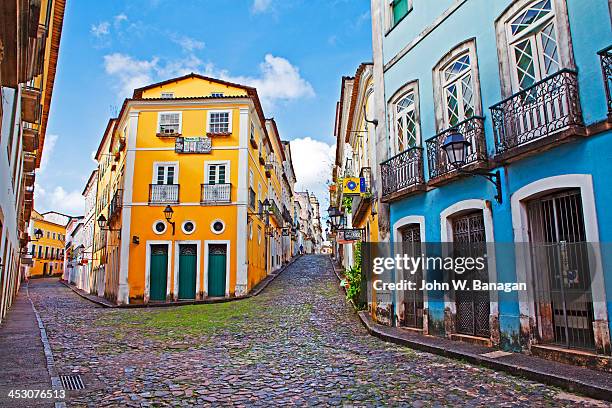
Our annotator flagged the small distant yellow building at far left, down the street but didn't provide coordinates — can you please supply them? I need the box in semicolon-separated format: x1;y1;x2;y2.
27;210;69;278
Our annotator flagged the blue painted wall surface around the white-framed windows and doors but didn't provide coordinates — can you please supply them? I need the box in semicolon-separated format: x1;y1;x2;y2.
380;0;612;348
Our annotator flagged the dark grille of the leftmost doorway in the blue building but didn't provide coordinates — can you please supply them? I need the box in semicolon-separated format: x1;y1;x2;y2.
400;224;423;329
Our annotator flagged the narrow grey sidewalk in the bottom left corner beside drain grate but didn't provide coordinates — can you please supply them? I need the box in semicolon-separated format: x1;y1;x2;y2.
0;285;61;407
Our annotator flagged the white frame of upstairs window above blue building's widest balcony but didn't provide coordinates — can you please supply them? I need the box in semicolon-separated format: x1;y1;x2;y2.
495;0;576;98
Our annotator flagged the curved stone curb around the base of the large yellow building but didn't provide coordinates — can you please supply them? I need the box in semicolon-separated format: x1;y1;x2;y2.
59;255;302;309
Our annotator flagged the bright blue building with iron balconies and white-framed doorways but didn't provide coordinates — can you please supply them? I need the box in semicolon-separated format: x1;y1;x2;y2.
372;0;612;358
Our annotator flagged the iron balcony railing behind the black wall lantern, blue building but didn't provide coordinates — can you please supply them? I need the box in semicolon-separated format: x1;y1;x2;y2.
425;116;487;179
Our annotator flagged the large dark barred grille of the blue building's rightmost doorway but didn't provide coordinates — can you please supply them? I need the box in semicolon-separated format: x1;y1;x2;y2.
528;190;595;349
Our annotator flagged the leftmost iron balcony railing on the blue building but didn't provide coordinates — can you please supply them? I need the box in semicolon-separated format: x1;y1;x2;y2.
380;147;424;196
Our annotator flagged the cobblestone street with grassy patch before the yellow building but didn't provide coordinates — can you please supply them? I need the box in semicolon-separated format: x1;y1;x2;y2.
30;256;606;407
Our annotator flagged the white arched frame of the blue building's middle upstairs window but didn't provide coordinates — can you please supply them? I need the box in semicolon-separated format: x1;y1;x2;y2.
433;38;482;132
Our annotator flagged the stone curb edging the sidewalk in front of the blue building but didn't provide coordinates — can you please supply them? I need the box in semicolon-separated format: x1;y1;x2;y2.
329;257;612;401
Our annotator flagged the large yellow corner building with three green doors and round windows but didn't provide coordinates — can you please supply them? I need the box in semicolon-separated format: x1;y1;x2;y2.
93;74;298;304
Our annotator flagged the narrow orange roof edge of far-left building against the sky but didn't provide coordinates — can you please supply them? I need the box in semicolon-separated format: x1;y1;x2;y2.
36;0;66;167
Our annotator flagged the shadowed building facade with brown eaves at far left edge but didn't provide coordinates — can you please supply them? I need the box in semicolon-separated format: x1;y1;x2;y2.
0;0;65;320
